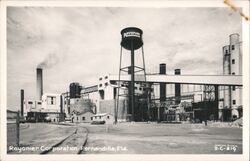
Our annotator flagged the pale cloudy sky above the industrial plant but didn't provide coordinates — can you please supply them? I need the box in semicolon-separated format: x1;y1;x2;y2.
7;7;242;110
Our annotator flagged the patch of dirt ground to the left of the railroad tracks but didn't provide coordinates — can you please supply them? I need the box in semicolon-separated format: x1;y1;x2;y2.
9;123;75;154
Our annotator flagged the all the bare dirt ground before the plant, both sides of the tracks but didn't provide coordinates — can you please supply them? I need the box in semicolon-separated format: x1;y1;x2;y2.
7;122;242;154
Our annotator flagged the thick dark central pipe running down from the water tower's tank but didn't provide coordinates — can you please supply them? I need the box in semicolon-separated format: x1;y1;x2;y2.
130;41;135;121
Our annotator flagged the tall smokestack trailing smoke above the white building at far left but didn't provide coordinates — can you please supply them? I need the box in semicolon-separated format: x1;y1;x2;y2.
36;68;43;100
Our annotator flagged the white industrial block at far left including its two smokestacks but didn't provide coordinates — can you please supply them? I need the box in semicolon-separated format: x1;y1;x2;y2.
21;68;65;122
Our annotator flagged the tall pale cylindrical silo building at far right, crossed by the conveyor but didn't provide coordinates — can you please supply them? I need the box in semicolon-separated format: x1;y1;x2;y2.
219;34;242;121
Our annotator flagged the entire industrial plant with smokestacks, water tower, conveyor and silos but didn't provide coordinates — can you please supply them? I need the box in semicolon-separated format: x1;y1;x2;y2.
20;27;243;124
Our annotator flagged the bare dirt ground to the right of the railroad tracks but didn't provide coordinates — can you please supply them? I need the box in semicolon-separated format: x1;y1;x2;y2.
80;123;242;154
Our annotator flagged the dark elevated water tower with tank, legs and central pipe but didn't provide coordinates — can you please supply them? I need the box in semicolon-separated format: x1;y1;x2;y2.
115;27;147;122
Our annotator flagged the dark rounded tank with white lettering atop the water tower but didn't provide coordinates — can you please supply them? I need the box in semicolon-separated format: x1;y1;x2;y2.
121;27;143;50
